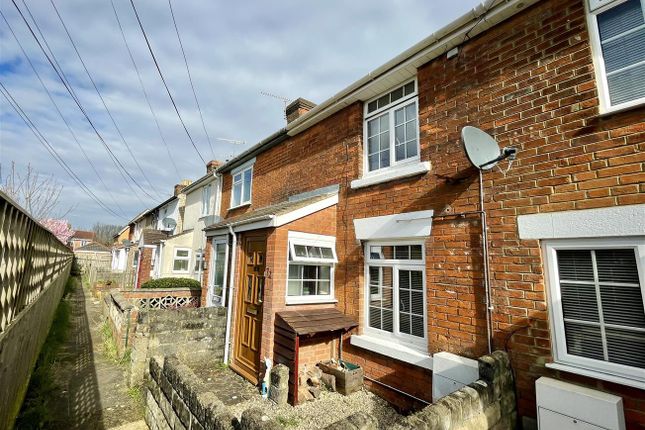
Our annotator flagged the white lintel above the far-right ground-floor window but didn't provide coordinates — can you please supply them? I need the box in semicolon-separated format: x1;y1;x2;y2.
517;205;645;239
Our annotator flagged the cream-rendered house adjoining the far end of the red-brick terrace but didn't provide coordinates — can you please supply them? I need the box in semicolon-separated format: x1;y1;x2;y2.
156;160;221;281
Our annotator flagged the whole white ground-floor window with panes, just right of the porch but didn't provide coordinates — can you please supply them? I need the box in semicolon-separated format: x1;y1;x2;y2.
364;241;428;352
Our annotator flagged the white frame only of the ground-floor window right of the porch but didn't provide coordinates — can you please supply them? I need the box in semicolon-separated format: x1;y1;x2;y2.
362;240;428;354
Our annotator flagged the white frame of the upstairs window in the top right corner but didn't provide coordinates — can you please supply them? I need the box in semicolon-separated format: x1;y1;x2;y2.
584;0;645;115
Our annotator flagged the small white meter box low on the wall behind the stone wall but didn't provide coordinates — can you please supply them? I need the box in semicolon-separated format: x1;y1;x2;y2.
432;352;479;402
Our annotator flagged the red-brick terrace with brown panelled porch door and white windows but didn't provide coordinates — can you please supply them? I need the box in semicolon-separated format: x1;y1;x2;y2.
202;0;645;428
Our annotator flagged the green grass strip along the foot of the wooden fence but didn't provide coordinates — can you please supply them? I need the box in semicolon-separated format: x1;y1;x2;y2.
15;277;79;429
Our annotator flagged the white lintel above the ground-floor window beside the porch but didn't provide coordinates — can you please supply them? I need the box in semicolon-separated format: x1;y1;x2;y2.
354;210;434;240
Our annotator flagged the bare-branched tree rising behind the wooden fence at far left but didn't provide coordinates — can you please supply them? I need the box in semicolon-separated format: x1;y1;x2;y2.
0;161;73;220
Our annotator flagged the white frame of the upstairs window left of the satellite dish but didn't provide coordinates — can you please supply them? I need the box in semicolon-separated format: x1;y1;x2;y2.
362;77;421;178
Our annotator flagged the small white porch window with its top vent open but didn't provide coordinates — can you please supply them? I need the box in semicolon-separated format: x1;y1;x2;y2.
286;232;338;304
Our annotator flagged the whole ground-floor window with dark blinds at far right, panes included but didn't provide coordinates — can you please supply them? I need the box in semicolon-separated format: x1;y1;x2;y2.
544;238;645;388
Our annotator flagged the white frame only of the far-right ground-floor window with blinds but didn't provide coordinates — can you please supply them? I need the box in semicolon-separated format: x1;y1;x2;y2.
542;237;645;387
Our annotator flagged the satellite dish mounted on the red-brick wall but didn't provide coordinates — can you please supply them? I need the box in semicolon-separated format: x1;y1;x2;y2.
461;126;517;170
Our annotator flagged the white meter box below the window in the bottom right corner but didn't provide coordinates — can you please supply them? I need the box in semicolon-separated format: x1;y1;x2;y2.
535;377;625;430
